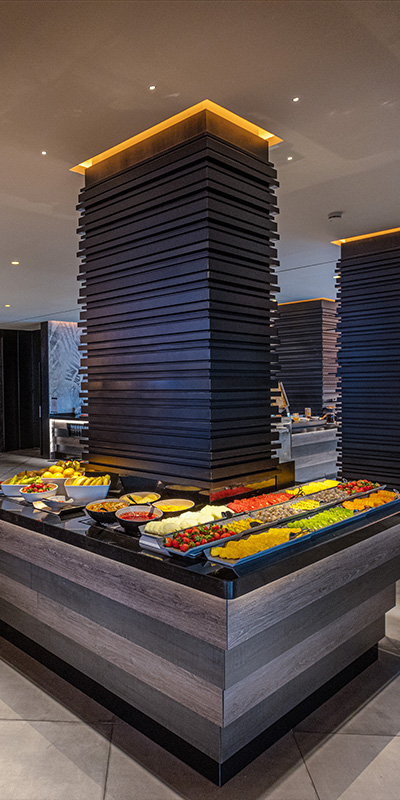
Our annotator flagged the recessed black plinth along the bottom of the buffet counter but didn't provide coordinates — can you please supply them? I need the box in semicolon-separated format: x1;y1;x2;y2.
0;622;378;786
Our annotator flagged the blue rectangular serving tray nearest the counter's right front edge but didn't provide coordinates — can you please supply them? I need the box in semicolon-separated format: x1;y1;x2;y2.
206;489;400;569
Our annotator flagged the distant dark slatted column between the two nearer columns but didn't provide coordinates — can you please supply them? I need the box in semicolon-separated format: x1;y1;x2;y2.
278;298;337;415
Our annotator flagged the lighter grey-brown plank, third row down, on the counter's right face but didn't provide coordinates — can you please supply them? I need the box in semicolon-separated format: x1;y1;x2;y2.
224;586;394;726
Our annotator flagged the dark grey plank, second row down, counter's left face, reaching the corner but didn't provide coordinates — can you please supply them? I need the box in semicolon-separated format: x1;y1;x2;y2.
31;562;226;688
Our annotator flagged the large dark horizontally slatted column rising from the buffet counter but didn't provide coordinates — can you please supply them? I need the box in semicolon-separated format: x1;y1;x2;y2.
79;112;277;486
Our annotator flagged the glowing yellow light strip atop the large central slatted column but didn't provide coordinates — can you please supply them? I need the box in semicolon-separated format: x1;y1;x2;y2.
70;100;282;175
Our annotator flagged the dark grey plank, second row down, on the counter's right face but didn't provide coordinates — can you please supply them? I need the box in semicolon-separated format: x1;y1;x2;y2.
225;558;399;687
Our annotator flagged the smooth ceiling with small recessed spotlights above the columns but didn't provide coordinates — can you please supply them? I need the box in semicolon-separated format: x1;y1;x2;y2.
0;0;400;327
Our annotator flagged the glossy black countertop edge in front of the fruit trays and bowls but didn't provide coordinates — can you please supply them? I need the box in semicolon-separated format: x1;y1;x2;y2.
0;497;400;599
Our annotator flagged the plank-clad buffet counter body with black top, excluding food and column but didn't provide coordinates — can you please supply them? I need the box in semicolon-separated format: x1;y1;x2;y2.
0;498;400;784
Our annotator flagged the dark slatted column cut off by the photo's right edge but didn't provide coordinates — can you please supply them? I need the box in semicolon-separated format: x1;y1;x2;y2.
338;233;400;486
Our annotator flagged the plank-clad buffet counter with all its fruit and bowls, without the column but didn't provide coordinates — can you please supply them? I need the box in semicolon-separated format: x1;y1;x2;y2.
0;464;400;784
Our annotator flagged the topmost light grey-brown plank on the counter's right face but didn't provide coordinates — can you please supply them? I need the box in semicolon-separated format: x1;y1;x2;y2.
227;525;400;648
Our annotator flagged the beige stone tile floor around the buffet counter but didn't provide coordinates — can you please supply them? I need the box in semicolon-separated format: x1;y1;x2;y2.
0;453;400;800
